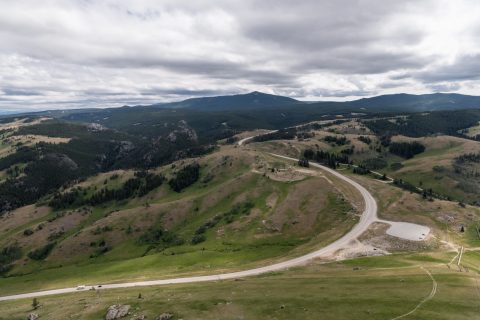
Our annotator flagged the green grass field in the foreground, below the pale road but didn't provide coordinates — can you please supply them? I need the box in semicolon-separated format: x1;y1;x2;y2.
0;252;480;320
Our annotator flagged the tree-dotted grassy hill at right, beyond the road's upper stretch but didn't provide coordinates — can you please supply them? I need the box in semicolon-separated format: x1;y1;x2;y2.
255;119;480;205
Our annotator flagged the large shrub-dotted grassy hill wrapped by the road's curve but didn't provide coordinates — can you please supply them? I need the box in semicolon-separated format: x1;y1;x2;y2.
0;146;357;294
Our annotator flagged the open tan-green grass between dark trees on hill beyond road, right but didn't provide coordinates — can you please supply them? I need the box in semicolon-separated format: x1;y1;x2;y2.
252;121;480;203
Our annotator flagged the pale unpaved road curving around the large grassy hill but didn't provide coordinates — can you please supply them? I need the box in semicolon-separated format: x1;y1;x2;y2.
0;154;377;301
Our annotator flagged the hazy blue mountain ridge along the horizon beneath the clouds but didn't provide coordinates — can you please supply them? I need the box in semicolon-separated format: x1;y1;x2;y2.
4;91;480;118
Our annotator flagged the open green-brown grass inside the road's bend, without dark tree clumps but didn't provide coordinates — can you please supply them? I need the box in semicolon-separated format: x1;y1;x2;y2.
0;147;355;294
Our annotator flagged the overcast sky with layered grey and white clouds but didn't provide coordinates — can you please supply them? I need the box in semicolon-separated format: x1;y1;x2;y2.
0;0;480;112
